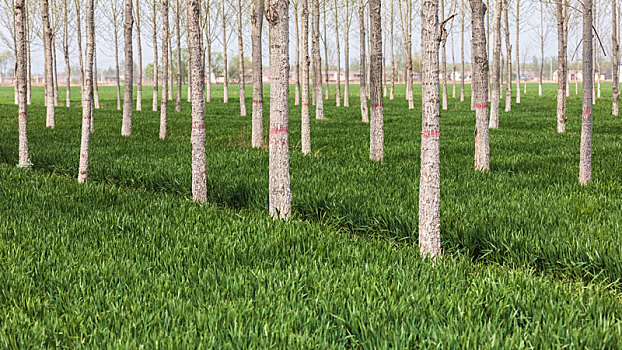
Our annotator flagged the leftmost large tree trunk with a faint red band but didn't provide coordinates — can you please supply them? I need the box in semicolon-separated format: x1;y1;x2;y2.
15;0;31;168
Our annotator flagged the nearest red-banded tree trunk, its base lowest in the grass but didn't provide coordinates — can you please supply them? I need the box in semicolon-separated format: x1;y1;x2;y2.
419;0;443;258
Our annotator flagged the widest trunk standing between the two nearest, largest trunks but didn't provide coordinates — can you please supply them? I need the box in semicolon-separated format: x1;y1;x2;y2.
369;0;384;161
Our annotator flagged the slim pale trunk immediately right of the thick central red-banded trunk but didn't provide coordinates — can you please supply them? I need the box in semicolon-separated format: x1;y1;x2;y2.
300;0;313;154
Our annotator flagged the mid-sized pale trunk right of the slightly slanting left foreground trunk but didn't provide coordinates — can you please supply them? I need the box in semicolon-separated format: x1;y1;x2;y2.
121;0;134;136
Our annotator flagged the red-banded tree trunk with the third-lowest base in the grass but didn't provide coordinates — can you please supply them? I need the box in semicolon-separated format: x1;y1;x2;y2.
187;0;207;202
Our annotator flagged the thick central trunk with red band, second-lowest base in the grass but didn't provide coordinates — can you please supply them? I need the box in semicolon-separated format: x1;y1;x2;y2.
266;0;292;219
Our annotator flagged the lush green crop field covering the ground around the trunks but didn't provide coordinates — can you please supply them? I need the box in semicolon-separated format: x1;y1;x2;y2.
0;85;622;349
